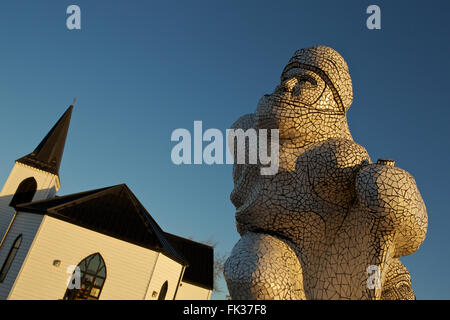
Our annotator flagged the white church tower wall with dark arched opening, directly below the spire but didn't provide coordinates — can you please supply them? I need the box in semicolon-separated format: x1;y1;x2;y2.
0;162;59;236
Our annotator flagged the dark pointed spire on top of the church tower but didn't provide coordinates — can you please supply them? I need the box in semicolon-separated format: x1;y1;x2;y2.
17;104;75;175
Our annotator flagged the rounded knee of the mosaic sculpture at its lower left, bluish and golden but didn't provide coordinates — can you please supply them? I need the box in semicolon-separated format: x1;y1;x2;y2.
224;232;305;300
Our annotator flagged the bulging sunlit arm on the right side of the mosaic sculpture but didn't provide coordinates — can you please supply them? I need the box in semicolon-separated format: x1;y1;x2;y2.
355;164;428;257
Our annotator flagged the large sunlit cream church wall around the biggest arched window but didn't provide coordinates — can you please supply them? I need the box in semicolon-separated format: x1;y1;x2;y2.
9;216;163;300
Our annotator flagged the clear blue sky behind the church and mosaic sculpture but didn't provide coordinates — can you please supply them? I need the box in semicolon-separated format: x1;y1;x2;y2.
0;0;450;299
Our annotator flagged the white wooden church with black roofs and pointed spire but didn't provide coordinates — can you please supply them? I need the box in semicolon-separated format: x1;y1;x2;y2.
0;106;214;300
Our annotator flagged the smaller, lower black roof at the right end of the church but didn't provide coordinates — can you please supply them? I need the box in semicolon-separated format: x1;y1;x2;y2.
164;233;214;290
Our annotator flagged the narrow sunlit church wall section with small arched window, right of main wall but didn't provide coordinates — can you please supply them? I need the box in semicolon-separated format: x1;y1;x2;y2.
145;253;183;300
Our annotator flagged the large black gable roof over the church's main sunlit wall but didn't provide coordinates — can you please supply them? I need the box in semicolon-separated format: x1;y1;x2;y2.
15;184;187;265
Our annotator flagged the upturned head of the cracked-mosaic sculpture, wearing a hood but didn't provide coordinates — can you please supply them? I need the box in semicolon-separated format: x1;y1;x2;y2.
256;46;353;144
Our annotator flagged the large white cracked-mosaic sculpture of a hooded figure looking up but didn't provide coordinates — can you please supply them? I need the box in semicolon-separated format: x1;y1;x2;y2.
224;46;428;300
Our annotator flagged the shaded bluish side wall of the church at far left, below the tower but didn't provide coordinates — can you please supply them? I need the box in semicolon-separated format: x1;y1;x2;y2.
0;212;43;300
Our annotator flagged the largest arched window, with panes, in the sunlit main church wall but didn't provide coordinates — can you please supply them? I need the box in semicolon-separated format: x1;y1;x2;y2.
64;253;106;300
